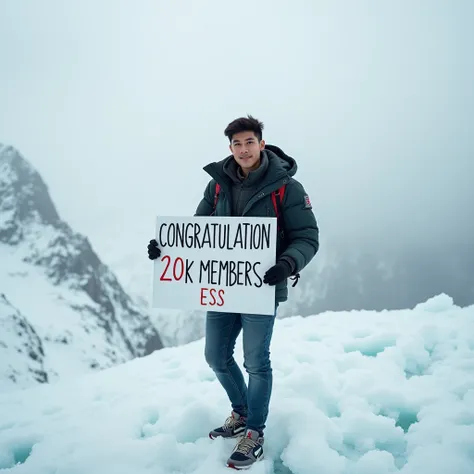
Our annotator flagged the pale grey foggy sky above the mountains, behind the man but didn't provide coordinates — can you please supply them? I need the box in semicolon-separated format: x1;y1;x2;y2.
0;0;474;286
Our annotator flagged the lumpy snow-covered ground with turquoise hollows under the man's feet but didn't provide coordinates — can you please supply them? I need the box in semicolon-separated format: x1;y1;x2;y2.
0;295;474;474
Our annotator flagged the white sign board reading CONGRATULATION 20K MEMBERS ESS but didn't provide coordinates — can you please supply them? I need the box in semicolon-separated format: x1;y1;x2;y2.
152;217;277;315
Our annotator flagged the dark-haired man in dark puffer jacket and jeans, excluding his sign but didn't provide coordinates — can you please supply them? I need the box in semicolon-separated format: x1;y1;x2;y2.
148;115;319;469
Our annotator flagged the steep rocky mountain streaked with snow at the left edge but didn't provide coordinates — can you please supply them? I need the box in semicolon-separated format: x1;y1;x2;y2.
0;145;163;385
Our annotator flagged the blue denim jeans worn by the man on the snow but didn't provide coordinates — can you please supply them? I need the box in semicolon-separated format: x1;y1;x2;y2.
205;310;276;434
